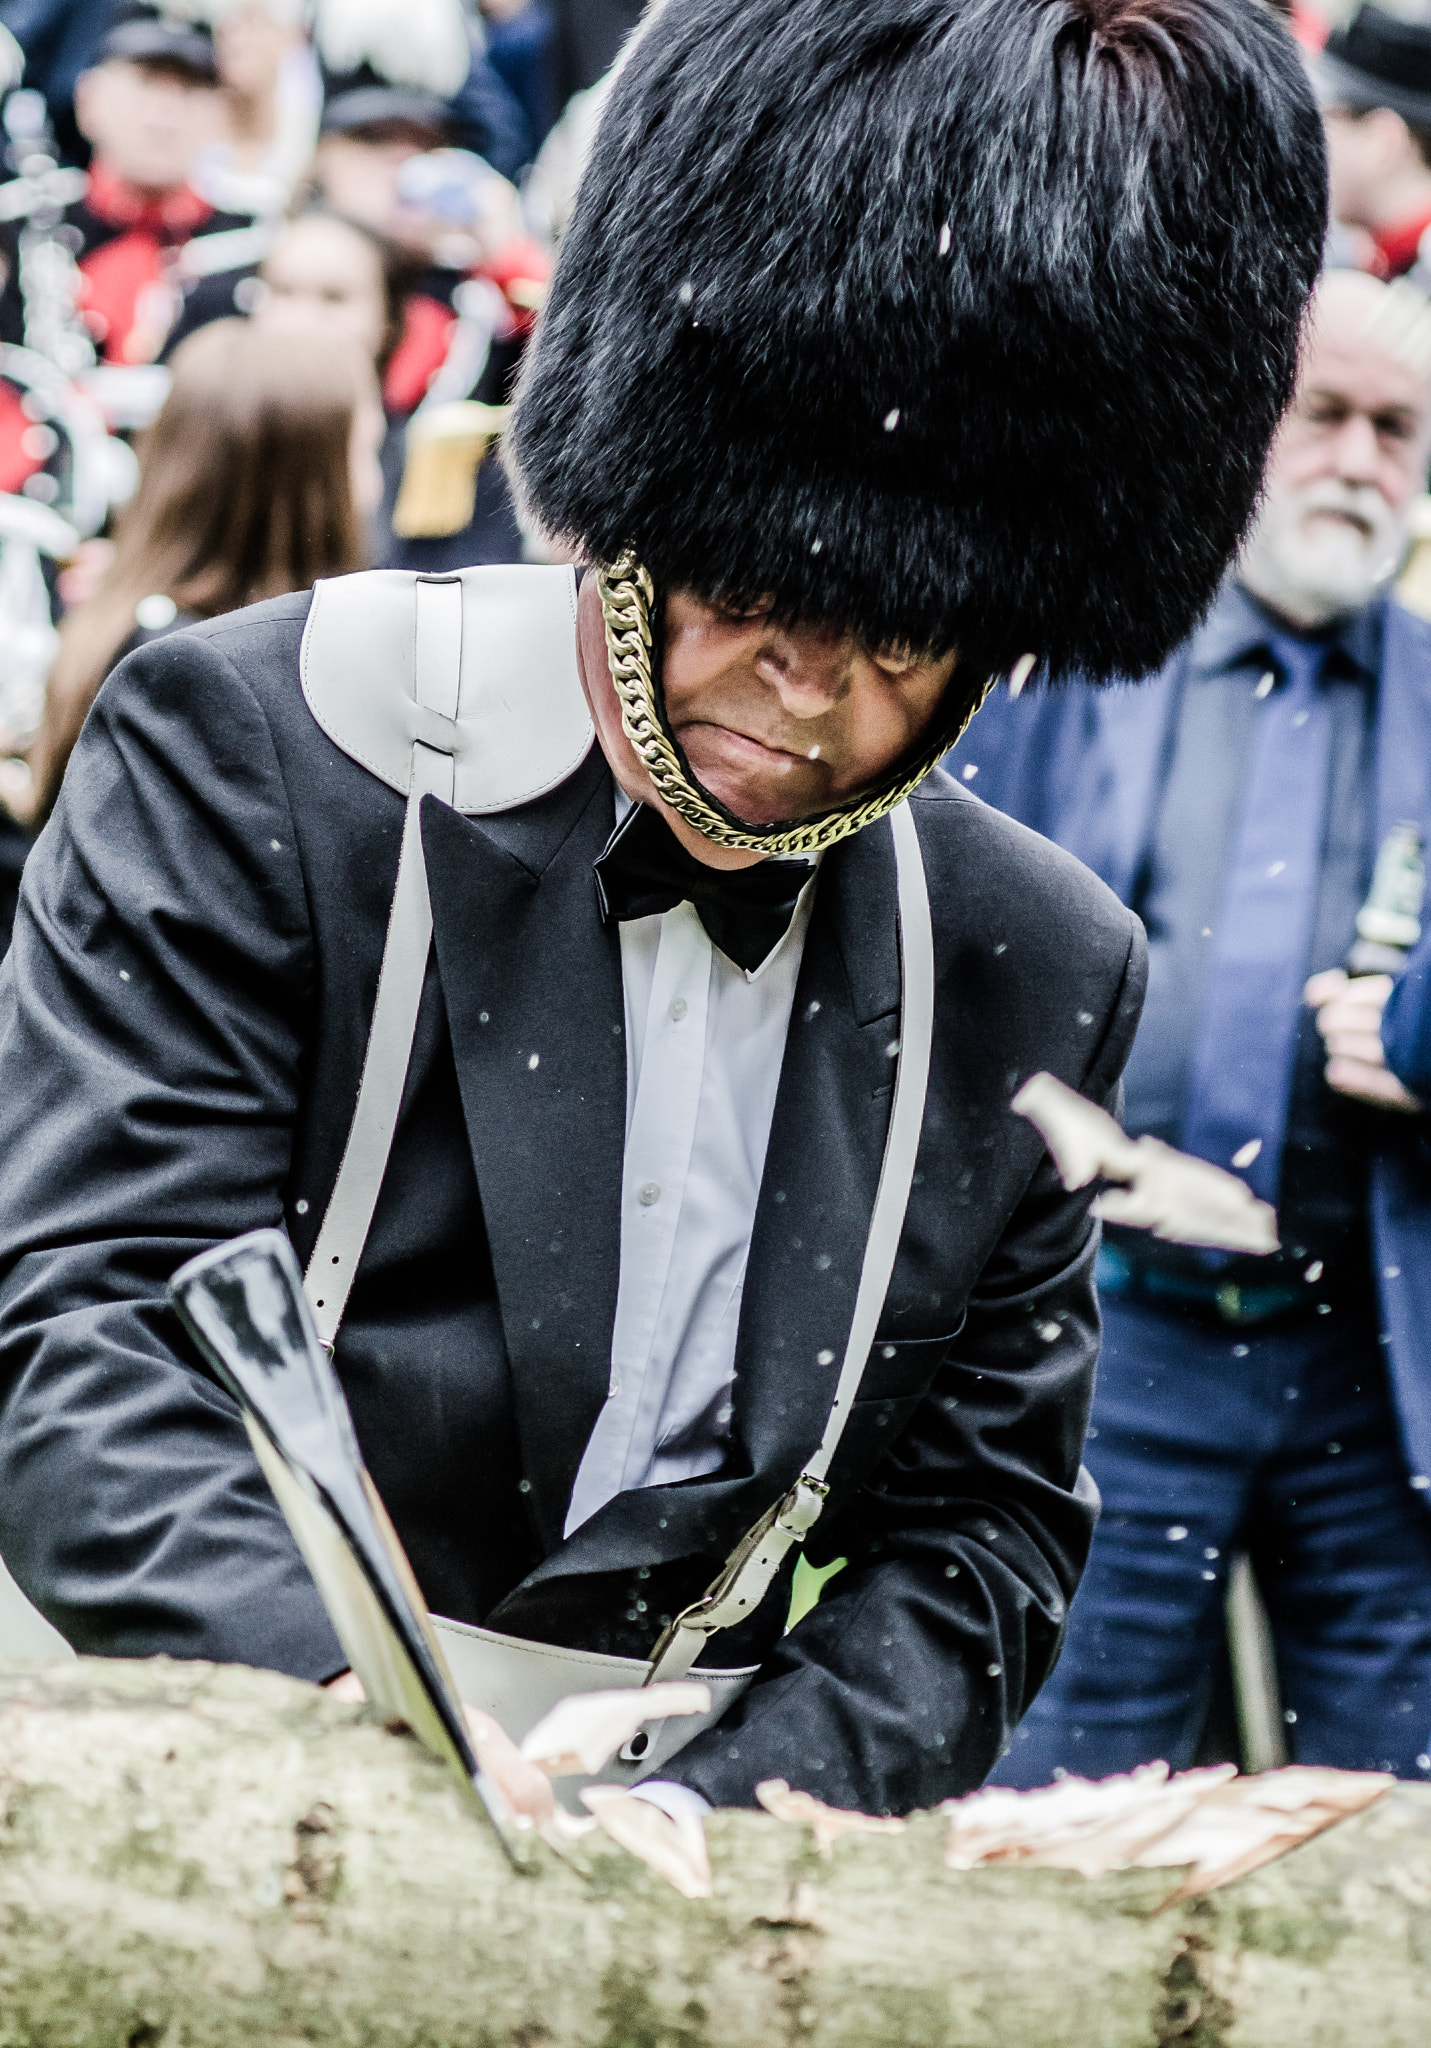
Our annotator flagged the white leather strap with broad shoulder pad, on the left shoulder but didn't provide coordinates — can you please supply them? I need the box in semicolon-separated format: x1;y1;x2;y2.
301;567;594;1350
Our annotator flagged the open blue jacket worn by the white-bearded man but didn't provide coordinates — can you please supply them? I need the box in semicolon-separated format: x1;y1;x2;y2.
948;602;1431;1477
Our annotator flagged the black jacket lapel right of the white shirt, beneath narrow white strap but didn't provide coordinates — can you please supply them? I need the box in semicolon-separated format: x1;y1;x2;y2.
509;823;899;1581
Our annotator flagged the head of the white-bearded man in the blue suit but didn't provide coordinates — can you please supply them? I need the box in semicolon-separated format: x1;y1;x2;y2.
1241;272;1431;627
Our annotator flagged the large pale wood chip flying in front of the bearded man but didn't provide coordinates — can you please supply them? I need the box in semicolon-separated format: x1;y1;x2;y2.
1011;1073;1277;1251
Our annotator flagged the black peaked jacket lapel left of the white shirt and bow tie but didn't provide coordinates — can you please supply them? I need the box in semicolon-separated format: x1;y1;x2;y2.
422;750;626;1546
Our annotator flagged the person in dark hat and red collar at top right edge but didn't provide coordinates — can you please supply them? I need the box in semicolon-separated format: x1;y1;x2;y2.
1310;4;1431;276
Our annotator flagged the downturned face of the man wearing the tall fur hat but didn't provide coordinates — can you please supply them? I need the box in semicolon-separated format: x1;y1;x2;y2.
581;578;956;852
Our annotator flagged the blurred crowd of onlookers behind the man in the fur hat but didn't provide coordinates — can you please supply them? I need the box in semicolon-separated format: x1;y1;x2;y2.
11;0;1431;1784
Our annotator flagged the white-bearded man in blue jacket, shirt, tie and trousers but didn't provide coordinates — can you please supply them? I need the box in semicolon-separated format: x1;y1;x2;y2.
958;272;1431;1784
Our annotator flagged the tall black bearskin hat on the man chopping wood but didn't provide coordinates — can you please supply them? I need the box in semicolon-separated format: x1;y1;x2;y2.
512;0;1327;678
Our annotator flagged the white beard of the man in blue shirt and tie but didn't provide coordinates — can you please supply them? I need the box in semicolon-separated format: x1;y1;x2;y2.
1239;477;1408;629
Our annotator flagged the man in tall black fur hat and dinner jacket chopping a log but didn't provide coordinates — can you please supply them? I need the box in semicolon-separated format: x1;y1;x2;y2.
0;0;1325;1812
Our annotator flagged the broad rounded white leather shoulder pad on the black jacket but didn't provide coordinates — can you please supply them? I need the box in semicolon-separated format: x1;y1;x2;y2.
299;565;594;815
